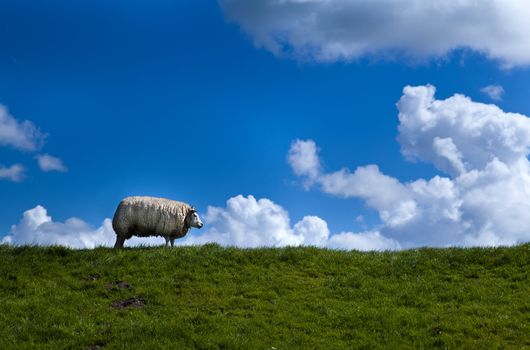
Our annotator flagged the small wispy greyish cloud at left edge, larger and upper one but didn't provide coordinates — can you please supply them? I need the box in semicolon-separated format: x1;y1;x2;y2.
0;105;45;151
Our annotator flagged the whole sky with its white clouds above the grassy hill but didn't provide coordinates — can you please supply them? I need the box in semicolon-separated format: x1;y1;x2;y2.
0;0;530;250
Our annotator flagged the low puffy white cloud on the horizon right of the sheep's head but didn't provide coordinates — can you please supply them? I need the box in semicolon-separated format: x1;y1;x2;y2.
178;195;399;250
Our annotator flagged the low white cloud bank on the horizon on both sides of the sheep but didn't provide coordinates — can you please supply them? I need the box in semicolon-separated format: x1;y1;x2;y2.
1;195;399;250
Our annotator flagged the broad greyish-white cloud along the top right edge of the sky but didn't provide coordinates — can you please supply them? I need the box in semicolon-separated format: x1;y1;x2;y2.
219;0;530;66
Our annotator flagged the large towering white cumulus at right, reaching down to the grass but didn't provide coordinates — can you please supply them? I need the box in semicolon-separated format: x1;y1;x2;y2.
288;85;530;247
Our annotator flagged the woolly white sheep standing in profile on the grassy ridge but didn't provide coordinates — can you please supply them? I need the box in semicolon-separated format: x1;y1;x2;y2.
112;197;203;248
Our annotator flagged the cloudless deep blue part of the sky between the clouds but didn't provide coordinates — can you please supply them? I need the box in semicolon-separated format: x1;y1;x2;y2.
0;1;530;249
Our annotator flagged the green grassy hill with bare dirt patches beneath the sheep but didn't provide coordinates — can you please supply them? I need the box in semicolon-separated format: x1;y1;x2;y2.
0;244;530;349
